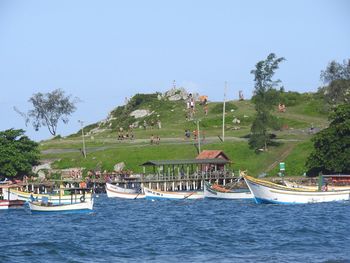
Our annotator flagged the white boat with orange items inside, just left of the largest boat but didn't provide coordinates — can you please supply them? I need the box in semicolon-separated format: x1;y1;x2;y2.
204;182;253;199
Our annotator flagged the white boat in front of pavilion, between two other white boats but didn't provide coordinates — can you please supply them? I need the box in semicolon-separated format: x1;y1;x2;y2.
143;187;204;200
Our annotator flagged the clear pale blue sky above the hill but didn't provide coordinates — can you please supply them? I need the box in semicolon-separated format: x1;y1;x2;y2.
0;0;350;140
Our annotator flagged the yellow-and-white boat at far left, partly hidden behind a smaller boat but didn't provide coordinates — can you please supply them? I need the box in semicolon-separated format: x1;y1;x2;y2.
3;187;91;204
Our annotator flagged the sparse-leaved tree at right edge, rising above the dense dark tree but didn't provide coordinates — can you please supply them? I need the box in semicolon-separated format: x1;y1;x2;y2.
319;59;350;106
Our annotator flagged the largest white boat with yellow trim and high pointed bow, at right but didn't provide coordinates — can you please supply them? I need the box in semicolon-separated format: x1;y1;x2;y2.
243;175;350;204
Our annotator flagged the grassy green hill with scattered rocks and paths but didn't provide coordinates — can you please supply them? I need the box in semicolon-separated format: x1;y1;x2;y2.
40;90;328;175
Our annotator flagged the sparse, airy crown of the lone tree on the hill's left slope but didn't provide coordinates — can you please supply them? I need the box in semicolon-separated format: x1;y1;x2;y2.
15;89;78;136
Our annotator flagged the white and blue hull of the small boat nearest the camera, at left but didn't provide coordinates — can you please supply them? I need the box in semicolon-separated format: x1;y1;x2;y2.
28;199;94;213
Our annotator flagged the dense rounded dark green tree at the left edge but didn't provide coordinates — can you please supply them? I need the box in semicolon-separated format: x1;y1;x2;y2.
0;129;40;177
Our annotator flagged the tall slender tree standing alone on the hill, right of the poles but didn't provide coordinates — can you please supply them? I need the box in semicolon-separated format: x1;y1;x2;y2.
249;53;285;153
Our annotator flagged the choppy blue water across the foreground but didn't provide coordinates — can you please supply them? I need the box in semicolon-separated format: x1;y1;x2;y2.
0;195;350;262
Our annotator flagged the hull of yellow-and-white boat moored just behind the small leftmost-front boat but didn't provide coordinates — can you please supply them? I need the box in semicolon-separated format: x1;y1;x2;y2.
3;189;91;205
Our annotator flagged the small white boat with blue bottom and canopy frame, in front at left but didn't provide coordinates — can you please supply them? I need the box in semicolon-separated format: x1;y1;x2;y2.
28;188;94;213
